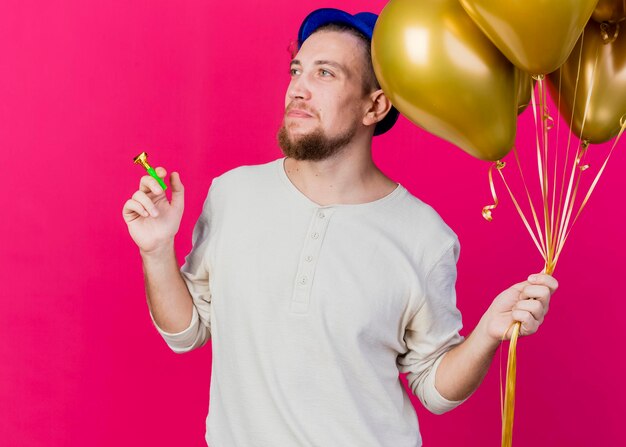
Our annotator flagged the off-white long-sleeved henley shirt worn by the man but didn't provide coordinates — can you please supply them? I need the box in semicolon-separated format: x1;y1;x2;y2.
153;158;463;447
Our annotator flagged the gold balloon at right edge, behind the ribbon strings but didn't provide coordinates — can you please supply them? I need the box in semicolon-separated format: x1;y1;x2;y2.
548;20;626;143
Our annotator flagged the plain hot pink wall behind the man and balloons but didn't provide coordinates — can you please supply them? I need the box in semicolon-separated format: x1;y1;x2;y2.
0;0;626;447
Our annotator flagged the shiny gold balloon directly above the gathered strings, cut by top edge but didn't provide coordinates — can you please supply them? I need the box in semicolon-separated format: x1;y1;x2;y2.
460;0;598;75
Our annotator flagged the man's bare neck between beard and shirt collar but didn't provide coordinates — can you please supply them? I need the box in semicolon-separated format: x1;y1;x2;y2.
285;147;397;206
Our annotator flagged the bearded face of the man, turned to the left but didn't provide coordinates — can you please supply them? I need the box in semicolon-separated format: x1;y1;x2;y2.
278;31;367;160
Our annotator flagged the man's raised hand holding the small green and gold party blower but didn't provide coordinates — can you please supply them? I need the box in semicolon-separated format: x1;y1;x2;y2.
122;167;185;254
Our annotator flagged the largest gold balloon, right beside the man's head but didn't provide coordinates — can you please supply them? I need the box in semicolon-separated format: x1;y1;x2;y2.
372;0;519;161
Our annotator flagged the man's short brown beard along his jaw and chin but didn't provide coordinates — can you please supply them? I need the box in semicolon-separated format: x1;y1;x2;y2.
278;121;357;161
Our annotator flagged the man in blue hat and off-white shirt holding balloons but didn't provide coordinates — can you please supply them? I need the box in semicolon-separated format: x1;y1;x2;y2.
123;9;557;447
